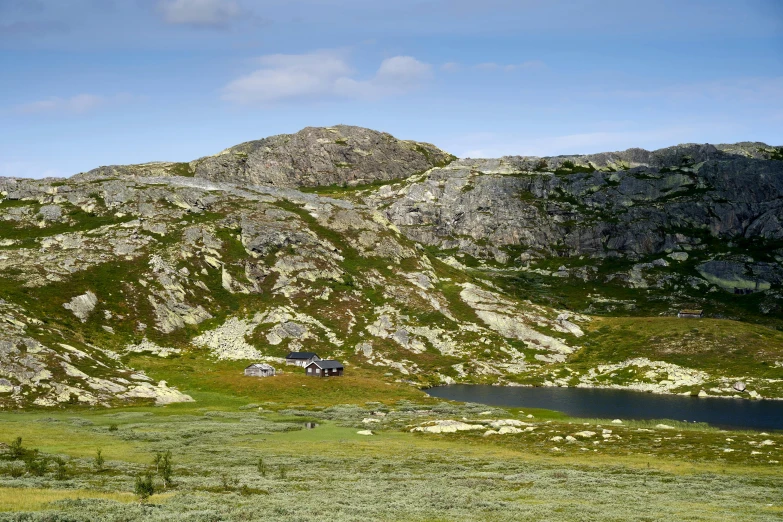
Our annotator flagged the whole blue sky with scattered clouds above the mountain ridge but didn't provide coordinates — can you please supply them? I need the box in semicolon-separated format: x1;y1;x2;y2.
0;0;783;177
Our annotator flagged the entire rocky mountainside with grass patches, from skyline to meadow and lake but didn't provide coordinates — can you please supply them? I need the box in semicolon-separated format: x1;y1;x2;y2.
0;125;783;408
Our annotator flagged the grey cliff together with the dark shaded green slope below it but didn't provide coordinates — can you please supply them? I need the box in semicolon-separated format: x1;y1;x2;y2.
366;143;783;316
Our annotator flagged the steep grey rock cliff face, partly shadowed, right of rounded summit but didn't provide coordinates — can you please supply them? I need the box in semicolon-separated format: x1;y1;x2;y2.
374;141;783;260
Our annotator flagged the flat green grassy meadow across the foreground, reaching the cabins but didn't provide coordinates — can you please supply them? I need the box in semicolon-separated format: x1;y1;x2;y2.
0;362;783;521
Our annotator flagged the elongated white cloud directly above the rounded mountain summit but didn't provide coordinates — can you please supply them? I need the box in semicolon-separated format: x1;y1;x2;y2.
223;51;432;105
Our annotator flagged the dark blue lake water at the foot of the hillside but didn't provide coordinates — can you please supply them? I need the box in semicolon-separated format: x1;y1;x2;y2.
427;384;783;430
